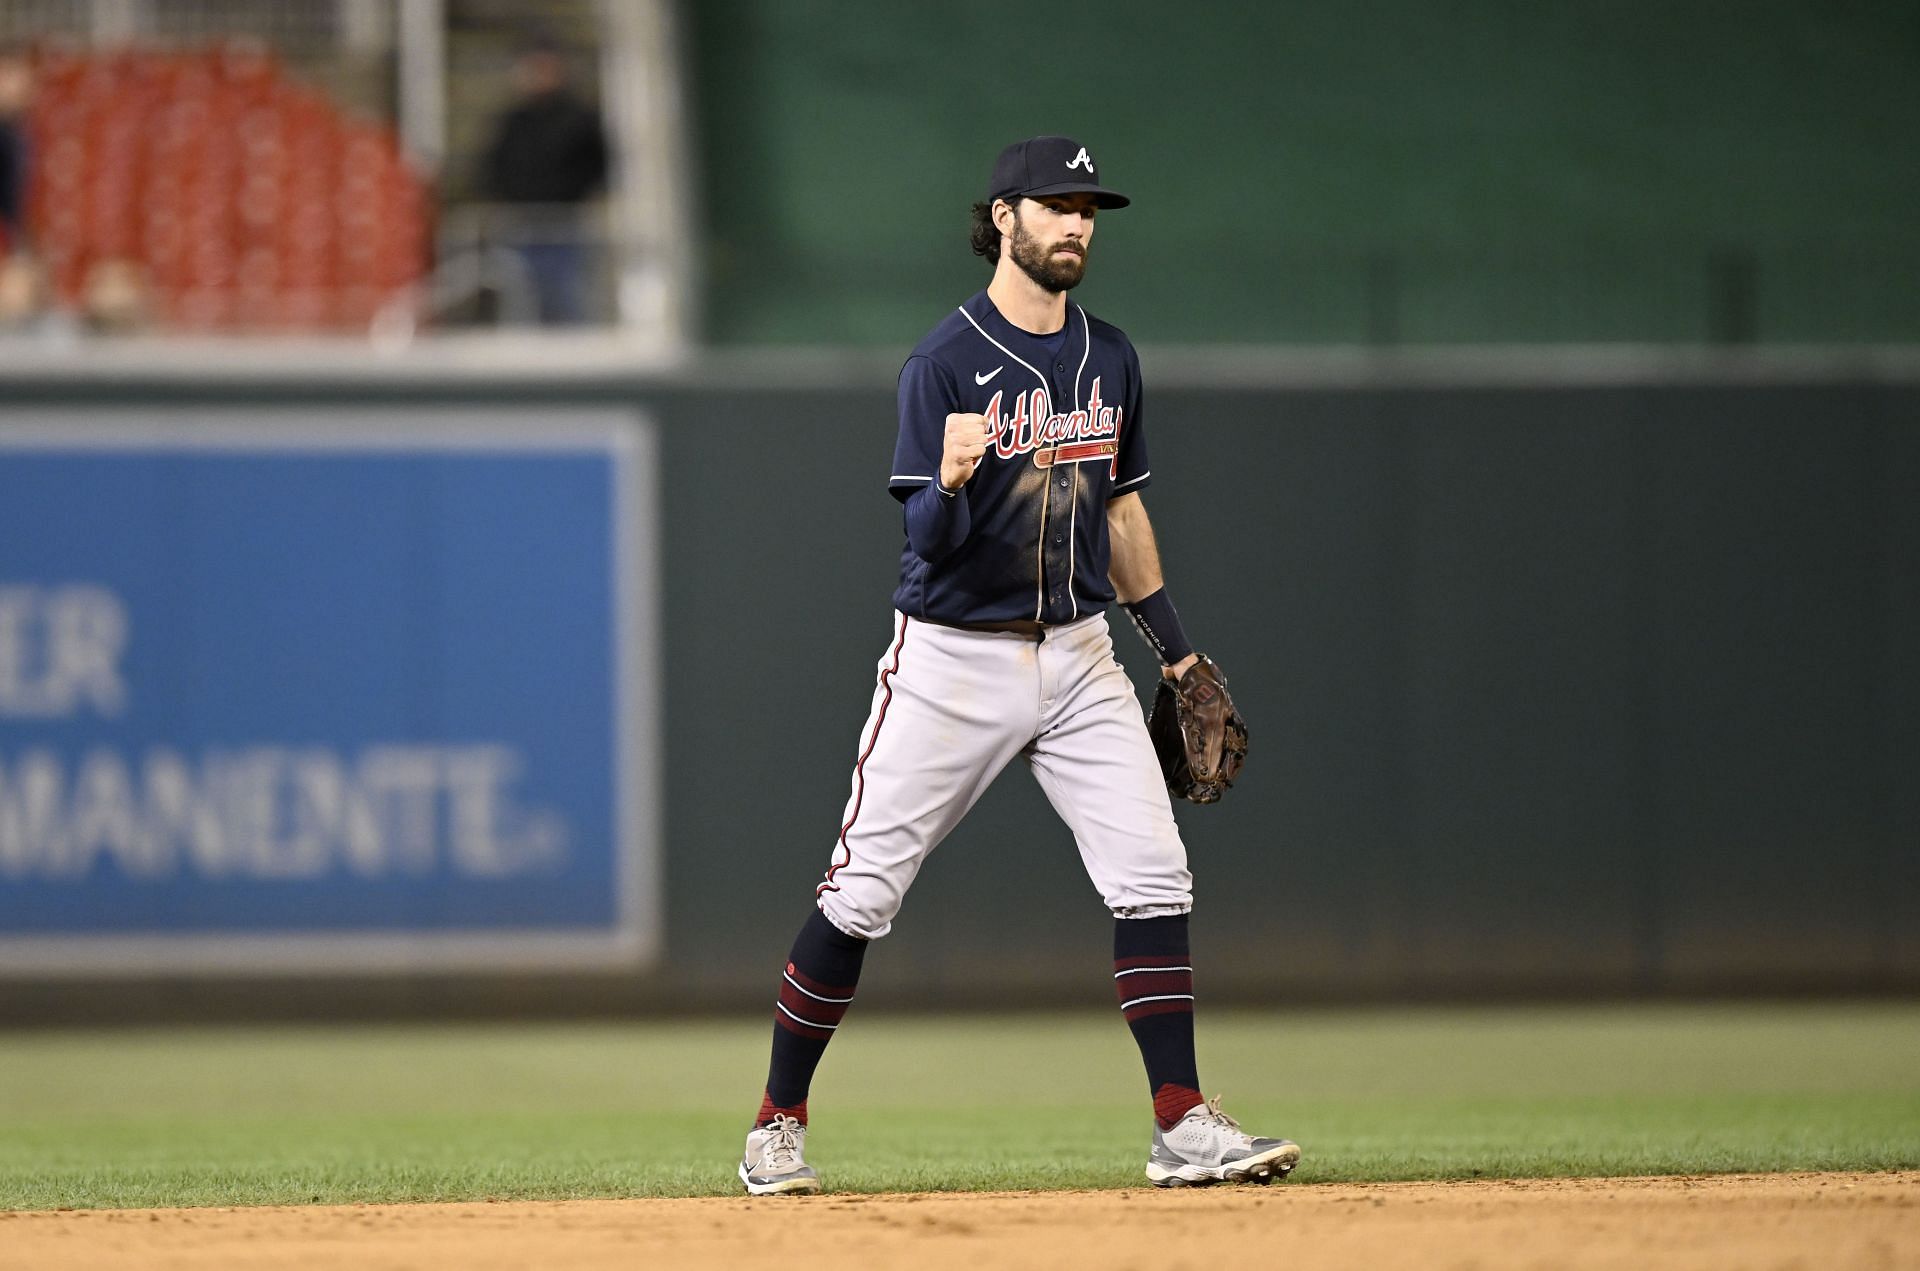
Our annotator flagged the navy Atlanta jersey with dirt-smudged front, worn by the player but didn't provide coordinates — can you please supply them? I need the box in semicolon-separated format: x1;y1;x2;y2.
889;292;1148;624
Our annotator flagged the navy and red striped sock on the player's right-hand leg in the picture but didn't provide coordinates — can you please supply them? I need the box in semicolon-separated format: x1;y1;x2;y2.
1114;914;1202;1129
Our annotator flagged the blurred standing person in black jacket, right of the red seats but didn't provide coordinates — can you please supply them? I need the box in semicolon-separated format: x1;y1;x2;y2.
480;38;607;324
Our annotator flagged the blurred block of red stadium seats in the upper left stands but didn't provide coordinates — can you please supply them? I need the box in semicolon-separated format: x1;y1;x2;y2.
29;40;426;330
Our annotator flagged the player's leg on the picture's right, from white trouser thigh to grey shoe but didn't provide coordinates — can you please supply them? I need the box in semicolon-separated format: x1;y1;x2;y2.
1027;618;1300;1187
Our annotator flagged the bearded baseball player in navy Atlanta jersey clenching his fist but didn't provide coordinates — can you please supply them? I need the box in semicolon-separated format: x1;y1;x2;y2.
739;136;1300;1194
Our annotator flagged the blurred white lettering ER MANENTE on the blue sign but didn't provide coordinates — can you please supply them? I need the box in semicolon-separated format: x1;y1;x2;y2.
0;584;566;879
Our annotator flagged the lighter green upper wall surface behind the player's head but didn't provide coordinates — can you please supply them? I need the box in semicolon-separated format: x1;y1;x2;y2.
684;0;1920;344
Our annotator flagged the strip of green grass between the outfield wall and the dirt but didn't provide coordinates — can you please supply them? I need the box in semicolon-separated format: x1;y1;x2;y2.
0;1004;1920;1210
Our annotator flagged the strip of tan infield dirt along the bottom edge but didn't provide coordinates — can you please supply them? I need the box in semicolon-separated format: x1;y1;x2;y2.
0;1173;1920;1271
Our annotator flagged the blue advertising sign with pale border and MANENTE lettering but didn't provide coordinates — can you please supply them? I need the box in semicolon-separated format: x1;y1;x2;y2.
0;407;660;973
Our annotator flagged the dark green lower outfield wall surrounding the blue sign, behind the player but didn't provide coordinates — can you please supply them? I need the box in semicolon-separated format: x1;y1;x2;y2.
0;357;1920;1014
